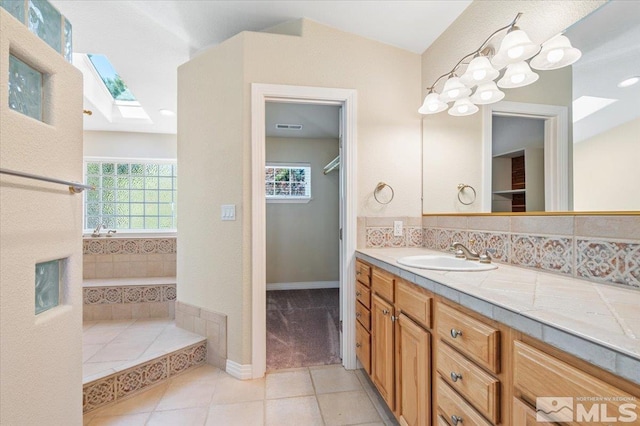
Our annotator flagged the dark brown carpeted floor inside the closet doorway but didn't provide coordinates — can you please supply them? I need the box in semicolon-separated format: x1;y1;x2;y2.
267;288;341;371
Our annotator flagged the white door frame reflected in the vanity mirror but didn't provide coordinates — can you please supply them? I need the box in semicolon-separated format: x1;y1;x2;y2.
481;101;573;212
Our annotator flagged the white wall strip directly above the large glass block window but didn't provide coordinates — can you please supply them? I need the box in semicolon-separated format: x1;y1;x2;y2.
84;131;178;160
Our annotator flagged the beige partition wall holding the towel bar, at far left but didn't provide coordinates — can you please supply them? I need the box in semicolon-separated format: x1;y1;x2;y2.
0;9;82;425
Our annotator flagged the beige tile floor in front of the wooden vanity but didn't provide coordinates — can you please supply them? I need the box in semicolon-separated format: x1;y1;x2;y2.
84;365;397;426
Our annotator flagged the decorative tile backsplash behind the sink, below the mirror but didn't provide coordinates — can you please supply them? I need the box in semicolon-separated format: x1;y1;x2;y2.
359;215;640;290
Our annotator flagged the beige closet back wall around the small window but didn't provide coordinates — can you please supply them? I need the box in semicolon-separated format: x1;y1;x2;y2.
265;138;340;285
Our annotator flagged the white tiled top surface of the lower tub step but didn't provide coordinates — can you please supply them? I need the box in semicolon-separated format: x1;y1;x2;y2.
82;318;204;383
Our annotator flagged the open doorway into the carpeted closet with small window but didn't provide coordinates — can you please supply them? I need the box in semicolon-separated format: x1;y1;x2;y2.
265;101;341;371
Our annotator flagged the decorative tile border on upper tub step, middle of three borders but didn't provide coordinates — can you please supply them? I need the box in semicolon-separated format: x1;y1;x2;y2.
82;284;176;305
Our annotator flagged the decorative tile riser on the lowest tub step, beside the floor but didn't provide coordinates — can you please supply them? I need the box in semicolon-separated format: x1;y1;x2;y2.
82;342;207;413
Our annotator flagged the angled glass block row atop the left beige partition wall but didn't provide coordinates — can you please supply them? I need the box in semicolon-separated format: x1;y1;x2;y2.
0;0;73;62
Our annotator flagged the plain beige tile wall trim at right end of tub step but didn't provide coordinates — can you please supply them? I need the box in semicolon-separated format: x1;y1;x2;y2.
176;301;227;370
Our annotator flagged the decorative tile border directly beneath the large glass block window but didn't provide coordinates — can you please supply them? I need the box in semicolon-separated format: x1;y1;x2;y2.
82;237;176;254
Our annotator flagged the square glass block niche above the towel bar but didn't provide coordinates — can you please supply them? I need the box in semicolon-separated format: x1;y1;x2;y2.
9;55;42;121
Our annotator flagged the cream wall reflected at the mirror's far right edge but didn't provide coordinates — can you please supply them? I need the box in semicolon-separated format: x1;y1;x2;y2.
573;118;640;211
